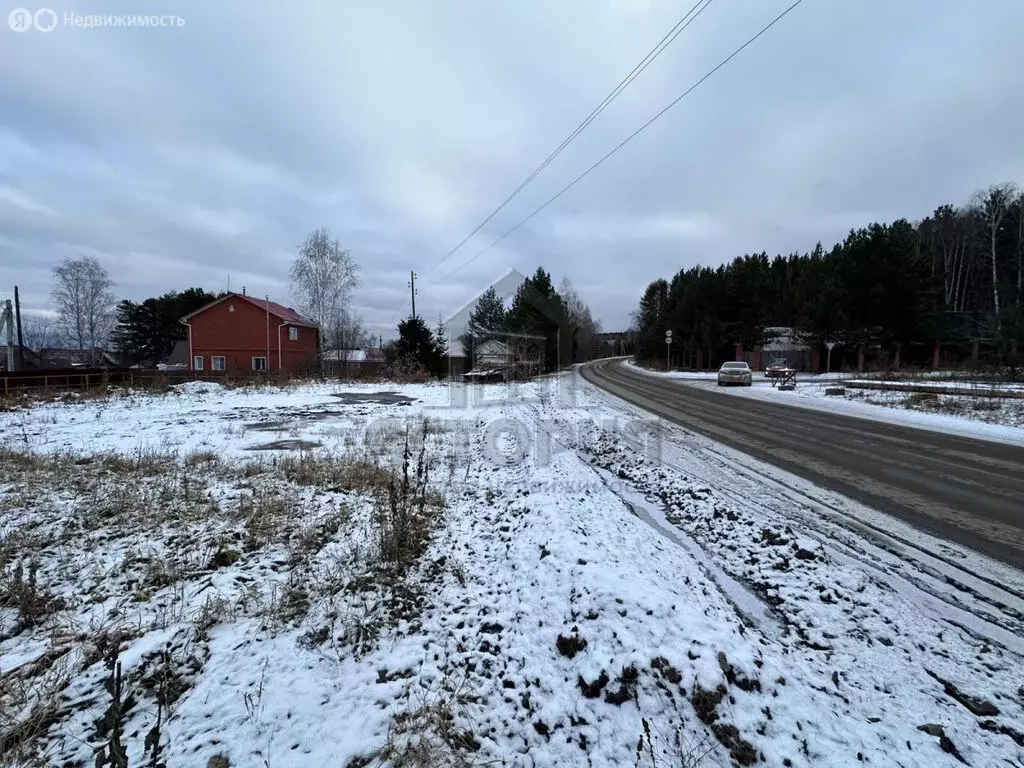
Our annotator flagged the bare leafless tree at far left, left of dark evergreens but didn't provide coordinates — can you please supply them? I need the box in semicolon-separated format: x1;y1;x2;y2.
51;256;117;360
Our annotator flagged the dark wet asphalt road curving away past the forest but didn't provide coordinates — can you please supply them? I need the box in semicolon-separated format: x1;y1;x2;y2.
583;359;1024;568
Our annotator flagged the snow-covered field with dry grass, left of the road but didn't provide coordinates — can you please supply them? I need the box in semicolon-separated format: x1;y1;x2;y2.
0;375;1024;768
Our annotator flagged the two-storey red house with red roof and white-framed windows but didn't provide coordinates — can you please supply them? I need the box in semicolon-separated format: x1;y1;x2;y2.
181;293;319;373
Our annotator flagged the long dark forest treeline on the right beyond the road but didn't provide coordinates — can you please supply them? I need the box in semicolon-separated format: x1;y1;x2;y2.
636;184;1024;366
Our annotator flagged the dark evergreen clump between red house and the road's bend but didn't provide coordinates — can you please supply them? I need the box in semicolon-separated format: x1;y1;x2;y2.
385;267;600;376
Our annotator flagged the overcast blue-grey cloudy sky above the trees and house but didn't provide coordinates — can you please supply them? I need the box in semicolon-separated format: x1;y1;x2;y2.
0;0;1024;337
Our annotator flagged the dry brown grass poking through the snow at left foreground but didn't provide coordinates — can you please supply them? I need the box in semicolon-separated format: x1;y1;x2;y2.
0;417;458;765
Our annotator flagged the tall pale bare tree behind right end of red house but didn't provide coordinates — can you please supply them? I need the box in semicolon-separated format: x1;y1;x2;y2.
290;226;360;346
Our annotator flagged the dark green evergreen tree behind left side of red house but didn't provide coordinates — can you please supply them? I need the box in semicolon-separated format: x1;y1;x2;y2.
111;288;217;365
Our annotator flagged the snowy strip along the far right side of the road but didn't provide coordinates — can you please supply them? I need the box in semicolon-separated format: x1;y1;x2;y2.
624;361;1024;445
